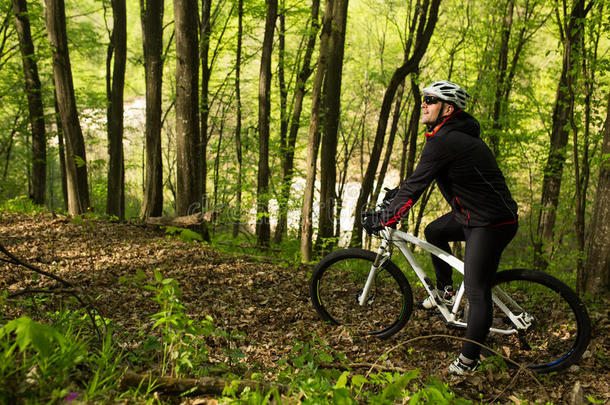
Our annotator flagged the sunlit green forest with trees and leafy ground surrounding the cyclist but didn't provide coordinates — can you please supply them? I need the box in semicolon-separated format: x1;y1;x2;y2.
0;0;610;404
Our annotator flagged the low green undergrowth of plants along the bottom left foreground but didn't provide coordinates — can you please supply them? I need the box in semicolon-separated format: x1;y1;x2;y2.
0;270;470;404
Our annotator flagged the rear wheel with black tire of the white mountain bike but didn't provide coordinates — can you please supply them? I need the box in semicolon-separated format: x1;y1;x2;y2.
488;269;591;373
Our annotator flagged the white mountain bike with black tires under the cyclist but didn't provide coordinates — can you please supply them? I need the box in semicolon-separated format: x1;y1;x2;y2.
309;228;591;373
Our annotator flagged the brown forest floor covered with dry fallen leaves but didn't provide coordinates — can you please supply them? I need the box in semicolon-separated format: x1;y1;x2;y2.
0;214;610;403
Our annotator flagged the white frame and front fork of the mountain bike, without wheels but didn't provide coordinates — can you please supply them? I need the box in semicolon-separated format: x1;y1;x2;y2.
358;228;533;335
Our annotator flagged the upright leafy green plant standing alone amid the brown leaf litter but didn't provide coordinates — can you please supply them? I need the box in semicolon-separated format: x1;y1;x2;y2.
145;270;214;376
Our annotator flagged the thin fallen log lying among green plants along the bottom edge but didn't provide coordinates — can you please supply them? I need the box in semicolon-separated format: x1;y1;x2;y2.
119;371;289;395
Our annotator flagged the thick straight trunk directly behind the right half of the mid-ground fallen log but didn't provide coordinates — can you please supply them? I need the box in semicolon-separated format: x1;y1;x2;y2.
174;0;202;215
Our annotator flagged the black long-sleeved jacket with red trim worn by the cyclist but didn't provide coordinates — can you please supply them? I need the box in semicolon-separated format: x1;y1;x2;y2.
381;111;517;226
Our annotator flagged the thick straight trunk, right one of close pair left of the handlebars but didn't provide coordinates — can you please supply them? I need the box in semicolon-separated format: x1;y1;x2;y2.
316;0;349;253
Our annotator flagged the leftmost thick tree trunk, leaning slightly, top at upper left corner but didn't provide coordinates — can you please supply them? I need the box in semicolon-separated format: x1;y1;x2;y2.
13;0;47;205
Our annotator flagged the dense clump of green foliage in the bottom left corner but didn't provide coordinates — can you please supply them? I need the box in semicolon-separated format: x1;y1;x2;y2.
0;311;122;403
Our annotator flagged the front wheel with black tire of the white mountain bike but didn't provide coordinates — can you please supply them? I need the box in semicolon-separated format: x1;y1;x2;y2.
309;249;413;338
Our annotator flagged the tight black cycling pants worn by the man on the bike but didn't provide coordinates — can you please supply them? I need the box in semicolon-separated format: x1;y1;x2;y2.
424;213;518;359
